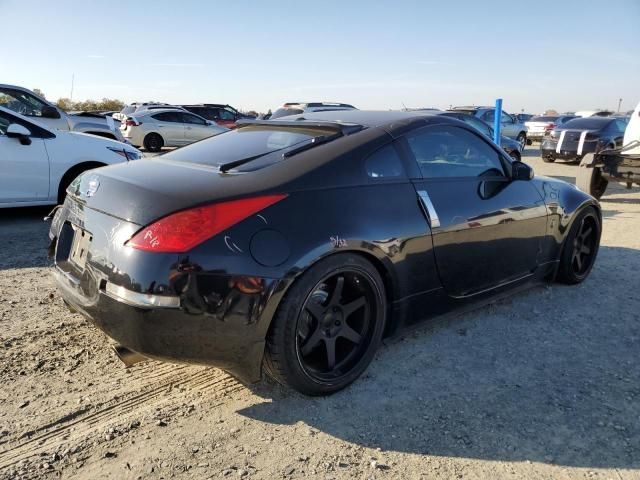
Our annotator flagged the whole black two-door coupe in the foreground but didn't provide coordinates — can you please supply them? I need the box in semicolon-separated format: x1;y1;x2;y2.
49;110;601;395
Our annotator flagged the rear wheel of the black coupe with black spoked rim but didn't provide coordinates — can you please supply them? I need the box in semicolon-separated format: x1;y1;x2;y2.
264;253;387;395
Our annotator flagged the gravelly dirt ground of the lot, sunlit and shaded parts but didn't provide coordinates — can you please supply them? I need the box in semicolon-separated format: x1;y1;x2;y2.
0;147;640;480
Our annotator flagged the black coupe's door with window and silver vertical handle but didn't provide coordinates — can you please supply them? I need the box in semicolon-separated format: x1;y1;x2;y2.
405;125;547;297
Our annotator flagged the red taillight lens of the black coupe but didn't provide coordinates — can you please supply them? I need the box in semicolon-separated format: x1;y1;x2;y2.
126;194;286;253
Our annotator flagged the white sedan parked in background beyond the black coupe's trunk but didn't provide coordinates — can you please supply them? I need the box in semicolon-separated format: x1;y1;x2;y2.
120;107;229;152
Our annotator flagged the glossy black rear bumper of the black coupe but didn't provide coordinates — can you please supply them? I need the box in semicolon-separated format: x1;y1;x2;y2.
49;201;279;383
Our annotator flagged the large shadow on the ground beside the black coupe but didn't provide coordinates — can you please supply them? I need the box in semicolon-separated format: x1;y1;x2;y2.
240;247;640;468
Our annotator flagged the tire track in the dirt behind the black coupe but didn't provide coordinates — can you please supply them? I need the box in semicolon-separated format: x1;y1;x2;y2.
0;362;244;469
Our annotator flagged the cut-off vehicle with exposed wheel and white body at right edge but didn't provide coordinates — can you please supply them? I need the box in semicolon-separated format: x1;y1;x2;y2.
576;103;640;198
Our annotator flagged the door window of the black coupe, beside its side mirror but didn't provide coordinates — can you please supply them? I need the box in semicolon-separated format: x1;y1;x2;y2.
407;125;505;178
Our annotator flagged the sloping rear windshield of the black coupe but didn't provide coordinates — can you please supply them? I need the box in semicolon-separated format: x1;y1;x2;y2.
162;125;336;171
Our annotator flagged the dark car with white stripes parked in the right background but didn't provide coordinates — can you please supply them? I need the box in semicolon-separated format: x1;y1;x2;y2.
540;116;627;163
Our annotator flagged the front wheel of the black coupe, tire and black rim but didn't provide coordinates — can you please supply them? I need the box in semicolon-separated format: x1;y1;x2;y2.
558;207;602;285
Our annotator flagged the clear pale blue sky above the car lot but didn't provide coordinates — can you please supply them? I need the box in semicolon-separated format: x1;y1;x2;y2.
0;0;640;113
